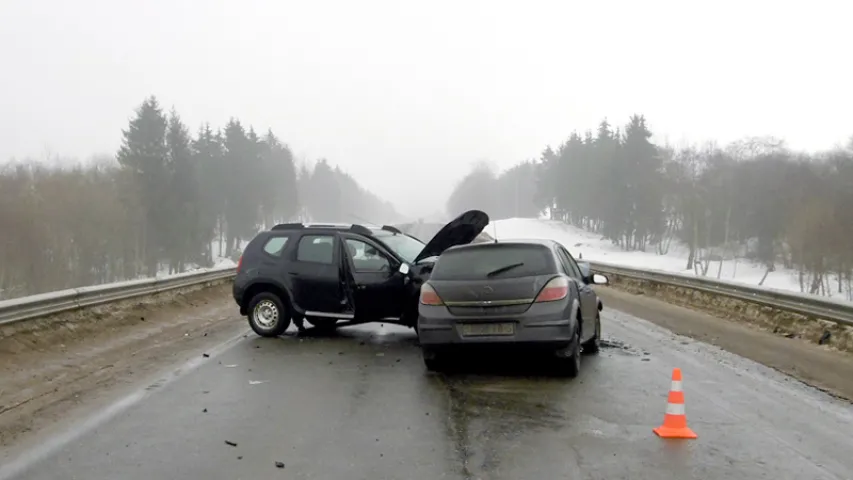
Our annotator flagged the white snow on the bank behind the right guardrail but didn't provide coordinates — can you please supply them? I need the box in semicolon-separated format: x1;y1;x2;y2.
485;218;846;299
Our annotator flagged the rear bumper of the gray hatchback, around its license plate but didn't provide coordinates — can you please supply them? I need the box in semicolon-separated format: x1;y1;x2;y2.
418;302;577;349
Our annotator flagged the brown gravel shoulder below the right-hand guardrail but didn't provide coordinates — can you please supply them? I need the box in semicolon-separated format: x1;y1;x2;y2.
596;288;853;400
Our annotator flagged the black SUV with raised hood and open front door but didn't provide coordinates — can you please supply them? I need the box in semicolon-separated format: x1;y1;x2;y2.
233;210;489;337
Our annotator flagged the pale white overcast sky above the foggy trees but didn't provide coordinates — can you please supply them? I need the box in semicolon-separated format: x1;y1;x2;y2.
0;0;853;215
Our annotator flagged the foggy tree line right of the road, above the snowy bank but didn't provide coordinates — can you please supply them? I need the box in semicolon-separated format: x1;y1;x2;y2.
448;115;853;299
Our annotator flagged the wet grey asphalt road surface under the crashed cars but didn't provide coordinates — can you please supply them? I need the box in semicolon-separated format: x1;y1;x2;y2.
0;310;853;480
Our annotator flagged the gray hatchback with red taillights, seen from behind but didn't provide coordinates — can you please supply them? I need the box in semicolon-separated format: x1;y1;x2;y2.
418;240;608;377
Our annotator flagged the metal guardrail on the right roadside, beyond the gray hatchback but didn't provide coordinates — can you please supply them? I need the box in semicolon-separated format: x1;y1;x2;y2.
588;262;853;326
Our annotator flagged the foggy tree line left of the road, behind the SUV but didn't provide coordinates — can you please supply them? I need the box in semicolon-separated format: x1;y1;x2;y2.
0;96;402;299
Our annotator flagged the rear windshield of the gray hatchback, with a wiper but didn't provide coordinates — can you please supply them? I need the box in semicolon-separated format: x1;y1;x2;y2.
430;244;555;280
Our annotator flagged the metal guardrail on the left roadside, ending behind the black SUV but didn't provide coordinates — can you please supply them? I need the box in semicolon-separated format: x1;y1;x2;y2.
0;267;236;325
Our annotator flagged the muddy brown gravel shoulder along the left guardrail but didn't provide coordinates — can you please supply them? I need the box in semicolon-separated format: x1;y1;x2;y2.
0;283;247;464
